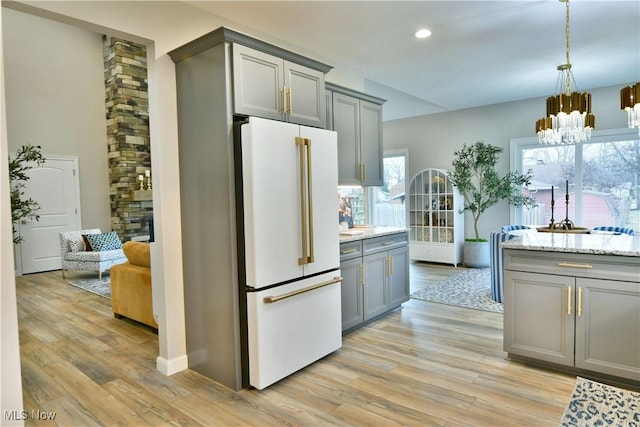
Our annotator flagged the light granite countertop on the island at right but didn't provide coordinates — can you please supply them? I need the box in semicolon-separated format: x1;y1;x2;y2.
500;232;640;257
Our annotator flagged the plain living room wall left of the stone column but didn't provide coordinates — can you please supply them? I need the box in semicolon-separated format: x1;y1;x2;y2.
2;8;111;231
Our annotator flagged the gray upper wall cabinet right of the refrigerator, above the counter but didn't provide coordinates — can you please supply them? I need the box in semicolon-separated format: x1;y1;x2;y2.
326;83;385;186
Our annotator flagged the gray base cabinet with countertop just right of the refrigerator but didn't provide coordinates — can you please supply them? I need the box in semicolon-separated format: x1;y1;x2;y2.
340;227;409;334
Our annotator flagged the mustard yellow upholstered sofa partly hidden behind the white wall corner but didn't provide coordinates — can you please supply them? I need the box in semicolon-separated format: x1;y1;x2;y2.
111;241;158;331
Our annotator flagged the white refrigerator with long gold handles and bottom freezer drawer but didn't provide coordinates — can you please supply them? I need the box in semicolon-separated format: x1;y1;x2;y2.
239;117;342;389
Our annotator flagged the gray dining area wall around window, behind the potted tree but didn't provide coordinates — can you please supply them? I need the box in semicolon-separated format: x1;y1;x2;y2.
384;83;627;238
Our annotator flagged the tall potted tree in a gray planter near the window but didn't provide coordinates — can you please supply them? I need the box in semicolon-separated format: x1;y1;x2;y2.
448;141;536;268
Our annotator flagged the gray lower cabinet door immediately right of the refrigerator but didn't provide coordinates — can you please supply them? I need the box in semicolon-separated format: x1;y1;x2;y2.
340;257;364;332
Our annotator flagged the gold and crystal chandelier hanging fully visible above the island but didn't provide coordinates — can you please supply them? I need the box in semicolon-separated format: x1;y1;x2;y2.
536;0;596;144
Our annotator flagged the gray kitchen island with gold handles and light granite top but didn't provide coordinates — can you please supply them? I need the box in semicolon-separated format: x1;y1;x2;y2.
501;233;640;387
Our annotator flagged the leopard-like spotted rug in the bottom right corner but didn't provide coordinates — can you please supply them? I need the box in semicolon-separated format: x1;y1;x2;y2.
560;377;640;427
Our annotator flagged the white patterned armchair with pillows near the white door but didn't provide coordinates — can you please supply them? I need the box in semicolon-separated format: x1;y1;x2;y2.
59;228;127;279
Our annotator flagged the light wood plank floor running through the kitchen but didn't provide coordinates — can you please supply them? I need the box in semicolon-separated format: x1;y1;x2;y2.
16;264;575;426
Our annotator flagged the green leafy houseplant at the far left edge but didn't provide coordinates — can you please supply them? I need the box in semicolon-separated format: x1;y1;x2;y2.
9;144;45;244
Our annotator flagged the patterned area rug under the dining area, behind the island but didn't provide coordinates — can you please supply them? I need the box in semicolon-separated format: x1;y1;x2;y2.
411;268;503;313
